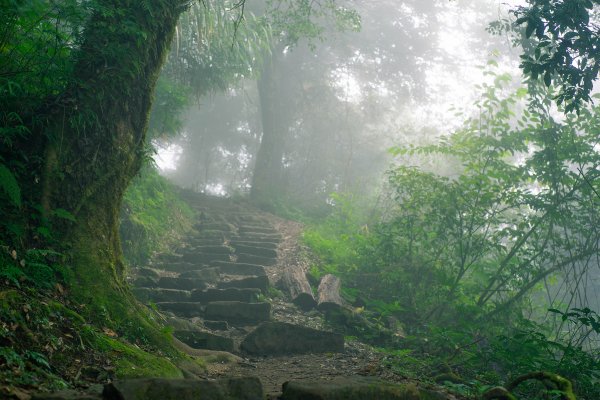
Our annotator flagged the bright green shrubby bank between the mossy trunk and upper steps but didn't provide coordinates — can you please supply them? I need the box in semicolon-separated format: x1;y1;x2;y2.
120;167;194;265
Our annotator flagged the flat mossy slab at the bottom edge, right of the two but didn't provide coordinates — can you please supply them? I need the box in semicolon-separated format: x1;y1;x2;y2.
280;376;449;400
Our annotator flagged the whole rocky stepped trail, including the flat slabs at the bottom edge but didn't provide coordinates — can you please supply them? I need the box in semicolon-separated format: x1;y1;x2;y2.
32;193;453;400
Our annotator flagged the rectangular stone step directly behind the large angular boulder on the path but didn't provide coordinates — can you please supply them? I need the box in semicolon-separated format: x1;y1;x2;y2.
205;301;271;325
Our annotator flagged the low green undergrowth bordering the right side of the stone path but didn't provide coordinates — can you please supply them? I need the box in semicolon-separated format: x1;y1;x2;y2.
303;193;600;400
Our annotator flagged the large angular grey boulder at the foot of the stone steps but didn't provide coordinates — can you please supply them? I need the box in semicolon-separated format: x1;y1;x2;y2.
240;322;344;356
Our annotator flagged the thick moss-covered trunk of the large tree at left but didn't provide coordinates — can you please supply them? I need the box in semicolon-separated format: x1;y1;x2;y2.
36;0;186;321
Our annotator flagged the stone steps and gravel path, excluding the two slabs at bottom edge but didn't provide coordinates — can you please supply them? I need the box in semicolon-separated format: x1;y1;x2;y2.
134;194;454;398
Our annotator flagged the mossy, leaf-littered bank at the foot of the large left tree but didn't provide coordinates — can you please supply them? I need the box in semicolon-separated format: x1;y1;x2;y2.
0;286;203;398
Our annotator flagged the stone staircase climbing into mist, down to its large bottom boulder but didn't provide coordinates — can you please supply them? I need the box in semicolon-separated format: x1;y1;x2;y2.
133;194;344;355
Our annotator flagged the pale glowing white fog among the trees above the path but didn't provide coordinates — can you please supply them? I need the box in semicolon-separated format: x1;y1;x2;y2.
154;0;520;205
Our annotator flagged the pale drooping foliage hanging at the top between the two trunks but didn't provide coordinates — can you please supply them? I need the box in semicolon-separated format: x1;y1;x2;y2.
163;0;271;96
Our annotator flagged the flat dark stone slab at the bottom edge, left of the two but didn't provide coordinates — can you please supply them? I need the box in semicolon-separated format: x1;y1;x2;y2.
103;377;264;400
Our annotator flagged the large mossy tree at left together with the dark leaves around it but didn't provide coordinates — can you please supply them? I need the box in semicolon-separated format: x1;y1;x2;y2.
0;0;189;332
